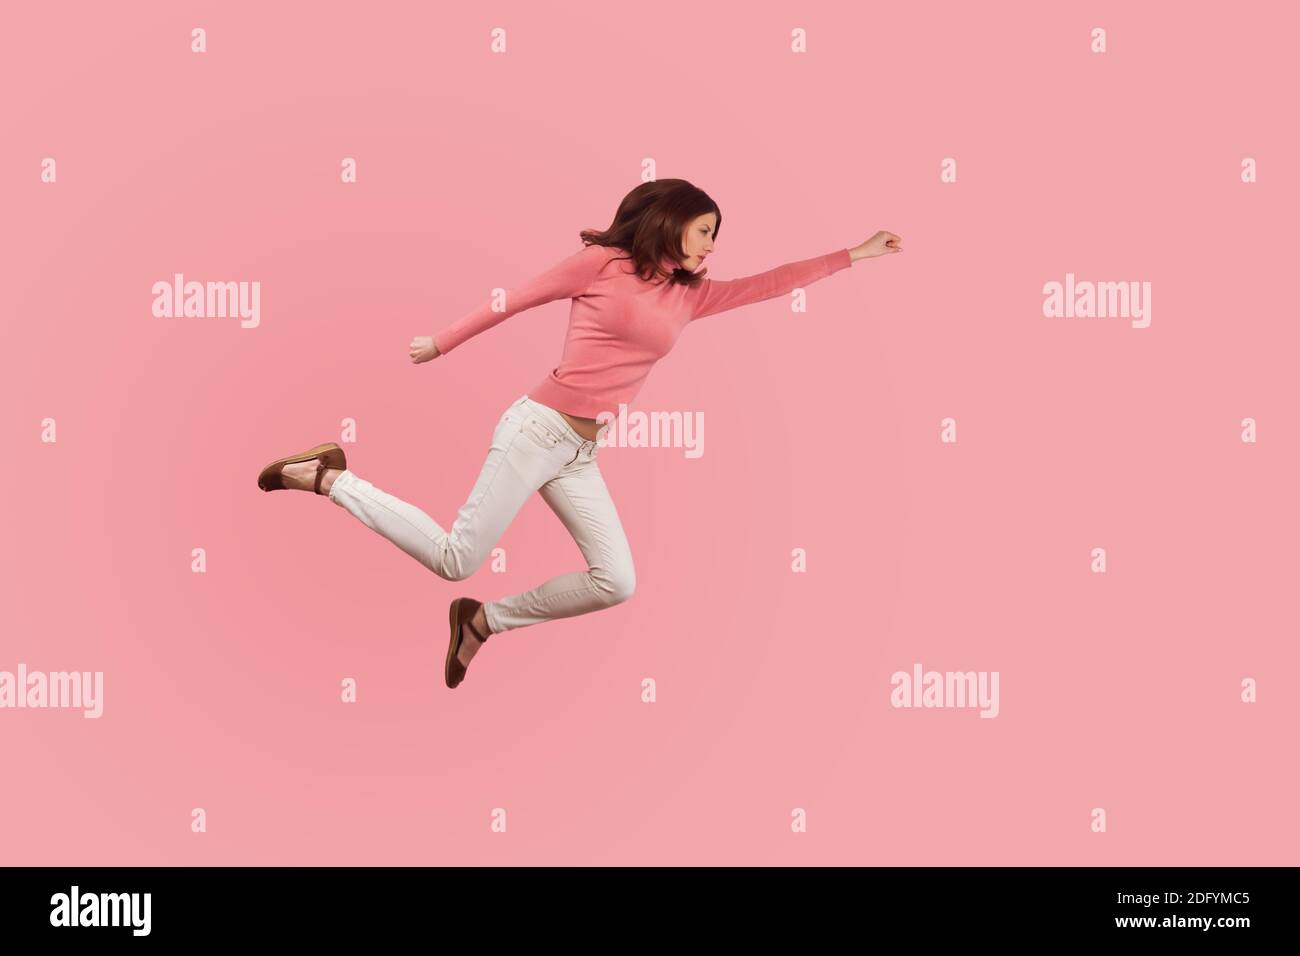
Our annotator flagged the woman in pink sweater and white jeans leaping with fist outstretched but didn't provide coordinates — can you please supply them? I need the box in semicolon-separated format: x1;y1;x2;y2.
257;179;902;687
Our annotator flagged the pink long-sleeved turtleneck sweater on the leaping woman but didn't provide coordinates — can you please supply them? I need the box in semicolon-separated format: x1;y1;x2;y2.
433;245;853;419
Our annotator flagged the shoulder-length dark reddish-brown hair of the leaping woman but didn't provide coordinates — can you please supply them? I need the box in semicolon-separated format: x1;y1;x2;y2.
579;179;723;286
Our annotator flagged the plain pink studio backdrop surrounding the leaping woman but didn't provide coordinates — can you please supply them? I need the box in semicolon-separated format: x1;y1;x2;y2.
0;1;1300;864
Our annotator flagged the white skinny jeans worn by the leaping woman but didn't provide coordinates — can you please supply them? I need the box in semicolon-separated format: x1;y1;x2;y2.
329;395;636;633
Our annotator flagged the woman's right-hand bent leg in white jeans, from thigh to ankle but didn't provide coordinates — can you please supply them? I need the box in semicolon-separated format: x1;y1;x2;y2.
484;457;636;633
